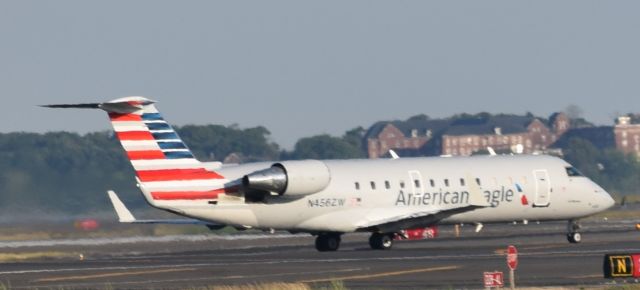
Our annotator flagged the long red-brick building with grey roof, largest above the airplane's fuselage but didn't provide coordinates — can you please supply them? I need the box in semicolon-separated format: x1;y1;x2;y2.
365;113;569;158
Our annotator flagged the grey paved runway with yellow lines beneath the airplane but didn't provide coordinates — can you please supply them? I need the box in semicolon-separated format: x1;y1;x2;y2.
0;222;640;289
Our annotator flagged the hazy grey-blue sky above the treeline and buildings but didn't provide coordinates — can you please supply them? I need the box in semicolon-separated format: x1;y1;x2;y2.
0;0;640;148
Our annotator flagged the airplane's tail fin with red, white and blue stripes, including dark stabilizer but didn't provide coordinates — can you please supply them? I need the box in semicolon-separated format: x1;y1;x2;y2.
45;97;226;206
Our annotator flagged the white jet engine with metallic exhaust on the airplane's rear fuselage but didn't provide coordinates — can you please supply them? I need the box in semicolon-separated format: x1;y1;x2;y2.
242;160;331;196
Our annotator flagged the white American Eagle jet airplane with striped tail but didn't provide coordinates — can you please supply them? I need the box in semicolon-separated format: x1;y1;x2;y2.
46;97;614;251
